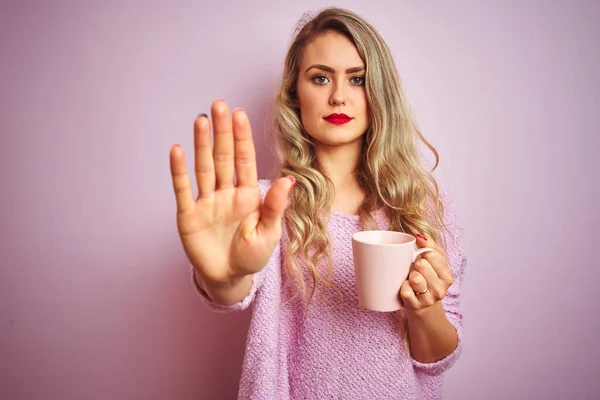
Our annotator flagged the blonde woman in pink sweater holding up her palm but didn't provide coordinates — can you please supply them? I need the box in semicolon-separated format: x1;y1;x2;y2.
171;8;466;399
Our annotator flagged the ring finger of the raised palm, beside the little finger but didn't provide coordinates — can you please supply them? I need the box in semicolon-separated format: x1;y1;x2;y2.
194;114;215;197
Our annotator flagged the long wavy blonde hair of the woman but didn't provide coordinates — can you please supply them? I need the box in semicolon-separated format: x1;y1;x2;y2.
273;8;443;307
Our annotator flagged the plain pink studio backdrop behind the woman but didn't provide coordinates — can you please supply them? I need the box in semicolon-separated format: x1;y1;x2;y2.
0;0;600;400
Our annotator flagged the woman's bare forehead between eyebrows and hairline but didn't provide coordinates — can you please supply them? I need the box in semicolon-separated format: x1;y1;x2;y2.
301;31;364;70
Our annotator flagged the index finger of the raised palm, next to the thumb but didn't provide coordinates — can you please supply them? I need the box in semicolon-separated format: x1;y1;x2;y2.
233;110;258;187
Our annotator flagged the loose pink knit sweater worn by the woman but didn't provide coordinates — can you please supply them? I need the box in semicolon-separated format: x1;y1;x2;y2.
195;180;466;400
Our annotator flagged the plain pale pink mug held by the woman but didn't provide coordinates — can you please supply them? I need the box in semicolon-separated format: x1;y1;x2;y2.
352;230;433;312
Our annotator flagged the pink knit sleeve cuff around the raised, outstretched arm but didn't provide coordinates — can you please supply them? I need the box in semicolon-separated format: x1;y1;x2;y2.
190;180;280;312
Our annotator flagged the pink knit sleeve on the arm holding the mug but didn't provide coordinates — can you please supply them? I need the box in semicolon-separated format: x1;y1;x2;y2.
412;186;467;375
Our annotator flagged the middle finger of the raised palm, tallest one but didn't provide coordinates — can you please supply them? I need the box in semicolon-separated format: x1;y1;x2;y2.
211;100;234;190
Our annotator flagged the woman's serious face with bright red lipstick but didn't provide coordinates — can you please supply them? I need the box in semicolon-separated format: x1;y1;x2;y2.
296;31;370;152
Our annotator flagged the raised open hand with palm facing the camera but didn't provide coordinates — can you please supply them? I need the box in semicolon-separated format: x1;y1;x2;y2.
170;100;295;285
